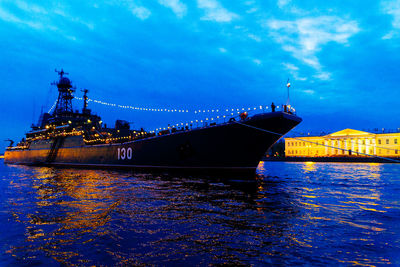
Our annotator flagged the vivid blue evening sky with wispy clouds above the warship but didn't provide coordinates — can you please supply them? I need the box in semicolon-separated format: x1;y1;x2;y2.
0;0;400;149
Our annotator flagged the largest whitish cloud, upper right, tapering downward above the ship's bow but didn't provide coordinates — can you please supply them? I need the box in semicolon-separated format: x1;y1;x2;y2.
266;16;360;80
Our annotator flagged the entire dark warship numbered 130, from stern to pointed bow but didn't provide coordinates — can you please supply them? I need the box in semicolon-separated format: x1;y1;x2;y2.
4;70;301;177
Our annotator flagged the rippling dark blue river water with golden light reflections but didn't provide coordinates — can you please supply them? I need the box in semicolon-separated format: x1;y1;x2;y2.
0;162;400;266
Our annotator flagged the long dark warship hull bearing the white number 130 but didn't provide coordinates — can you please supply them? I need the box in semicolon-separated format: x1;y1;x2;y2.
5;112;301;179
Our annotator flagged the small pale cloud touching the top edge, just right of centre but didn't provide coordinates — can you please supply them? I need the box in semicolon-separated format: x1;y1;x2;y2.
197;0;239;22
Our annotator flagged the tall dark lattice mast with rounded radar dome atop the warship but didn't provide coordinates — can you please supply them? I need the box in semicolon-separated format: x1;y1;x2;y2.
52;69;75;115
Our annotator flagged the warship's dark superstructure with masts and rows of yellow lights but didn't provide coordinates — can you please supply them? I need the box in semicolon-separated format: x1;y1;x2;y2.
14;70;147;152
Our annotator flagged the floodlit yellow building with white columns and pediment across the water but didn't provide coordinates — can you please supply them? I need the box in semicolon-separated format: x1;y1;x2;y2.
285;129;400;157
